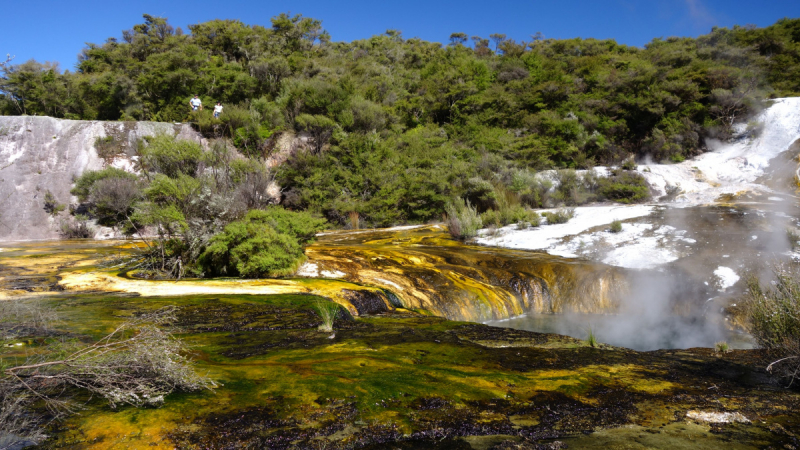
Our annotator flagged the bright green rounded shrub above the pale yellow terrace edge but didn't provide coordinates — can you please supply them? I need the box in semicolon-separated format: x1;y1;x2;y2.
198;207;326;278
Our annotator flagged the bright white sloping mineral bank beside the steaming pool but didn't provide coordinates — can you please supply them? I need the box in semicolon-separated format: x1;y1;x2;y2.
477;98;800;270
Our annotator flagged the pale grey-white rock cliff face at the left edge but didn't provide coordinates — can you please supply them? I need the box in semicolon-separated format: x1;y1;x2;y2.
0;116;202;241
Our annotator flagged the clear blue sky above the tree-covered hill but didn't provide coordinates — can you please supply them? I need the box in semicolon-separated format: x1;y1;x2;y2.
0;0;800;70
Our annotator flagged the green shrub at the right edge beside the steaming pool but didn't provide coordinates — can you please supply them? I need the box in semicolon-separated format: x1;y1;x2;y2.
745;266;800;385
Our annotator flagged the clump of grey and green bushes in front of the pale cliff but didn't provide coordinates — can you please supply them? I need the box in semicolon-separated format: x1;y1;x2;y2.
70;136;292;278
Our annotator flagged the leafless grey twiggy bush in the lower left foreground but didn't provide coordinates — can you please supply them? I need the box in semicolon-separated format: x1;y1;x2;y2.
0;301;217;440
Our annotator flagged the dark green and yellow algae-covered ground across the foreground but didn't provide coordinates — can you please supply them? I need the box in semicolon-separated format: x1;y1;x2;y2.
17;294;800;449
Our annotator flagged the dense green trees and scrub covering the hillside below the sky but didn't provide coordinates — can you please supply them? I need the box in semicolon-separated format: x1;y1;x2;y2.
0;14;800;226
